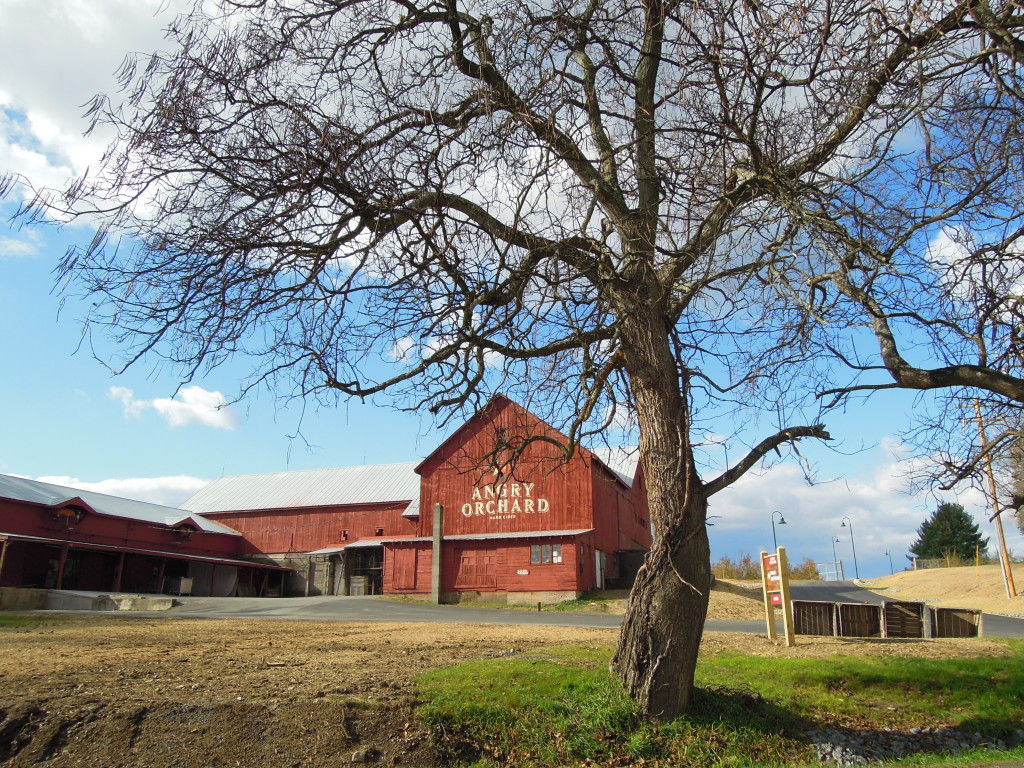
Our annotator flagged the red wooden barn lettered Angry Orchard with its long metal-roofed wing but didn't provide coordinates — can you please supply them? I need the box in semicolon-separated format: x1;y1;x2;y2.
183;396;651;602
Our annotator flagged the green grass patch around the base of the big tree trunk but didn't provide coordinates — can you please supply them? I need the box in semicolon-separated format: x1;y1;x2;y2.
417;642;1024;768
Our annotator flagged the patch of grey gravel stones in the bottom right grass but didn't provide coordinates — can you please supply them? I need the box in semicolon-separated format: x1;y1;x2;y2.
806;726;1024;766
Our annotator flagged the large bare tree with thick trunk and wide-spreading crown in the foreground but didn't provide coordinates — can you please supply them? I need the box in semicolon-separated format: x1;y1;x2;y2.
8;0;1016;719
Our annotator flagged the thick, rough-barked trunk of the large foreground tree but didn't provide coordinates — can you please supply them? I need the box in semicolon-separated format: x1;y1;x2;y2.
611;310;711;721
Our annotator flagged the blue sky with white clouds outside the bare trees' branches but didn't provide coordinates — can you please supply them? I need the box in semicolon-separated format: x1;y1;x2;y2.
0;0;1024;577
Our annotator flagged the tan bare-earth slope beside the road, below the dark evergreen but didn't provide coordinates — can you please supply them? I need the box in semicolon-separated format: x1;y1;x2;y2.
862;563;1024;616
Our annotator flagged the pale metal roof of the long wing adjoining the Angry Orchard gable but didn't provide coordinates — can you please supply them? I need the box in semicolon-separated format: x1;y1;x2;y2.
181;462;420;513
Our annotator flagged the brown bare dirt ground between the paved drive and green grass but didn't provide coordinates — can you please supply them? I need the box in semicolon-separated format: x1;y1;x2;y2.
0;569;1006;768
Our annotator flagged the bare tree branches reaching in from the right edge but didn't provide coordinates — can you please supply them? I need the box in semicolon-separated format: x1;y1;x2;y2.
790;2;1024;489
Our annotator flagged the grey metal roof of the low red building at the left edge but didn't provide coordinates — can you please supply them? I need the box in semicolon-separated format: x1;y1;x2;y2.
0;475;241;536
